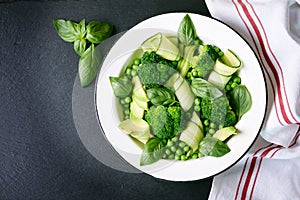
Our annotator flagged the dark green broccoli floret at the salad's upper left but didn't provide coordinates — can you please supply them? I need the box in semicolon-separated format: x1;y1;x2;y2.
137;52;176;88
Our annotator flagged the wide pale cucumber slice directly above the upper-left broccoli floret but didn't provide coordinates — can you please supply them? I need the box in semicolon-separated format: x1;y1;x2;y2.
156;33;180;61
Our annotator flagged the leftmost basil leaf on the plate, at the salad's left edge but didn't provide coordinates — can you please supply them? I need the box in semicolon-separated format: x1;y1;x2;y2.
109;76;133;98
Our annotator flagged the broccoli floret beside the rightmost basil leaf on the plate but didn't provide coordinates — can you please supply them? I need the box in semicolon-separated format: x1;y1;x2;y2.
201;96;237;127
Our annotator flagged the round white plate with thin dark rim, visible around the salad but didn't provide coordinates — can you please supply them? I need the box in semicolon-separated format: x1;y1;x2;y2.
95;13;267;181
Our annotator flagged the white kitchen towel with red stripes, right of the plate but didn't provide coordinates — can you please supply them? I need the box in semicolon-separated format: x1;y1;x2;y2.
206;0;300;200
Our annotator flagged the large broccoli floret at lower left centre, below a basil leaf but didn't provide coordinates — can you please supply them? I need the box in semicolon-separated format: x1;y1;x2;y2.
145;105;186;139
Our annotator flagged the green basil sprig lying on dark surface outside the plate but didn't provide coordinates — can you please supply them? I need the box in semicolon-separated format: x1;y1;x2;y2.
53;19;113;87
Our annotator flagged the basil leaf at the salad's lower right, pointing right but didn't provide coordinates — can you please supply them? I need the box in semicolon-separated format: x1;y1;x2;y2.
199;136;230;157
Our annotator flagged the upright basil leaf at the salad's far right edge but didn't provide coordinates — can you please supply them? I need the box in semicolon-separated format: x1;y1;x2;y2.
230;85;252;120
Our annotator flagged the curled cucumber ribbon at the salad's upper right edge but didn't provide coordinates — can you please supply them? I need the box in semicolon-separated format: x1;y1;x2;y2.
214;49;242;76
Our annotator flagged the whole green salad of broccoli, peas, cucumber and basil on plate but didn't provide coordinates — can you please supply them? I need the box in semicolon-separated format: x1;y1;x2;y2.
110;14;252;166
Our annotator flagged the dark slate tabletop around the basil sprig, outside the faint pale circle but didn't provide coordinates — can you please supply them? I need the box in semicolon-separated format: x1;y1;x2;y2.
0;0;212;200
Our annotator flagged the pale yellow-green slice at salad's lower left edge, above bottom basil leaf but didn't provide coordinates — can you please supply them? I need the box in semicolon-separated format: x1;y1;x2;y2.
118;119;151;144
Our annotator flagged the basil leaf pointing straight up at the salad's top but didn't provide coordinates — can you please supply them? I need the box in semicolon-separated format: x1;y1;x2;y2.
177;14;197;46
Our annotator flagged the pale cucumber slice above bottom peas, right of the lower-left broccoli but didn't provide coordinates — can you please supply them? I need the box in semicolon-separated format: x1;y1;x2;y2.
179;121;204;152
